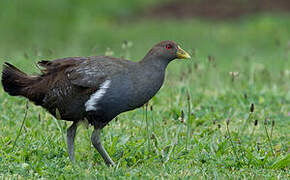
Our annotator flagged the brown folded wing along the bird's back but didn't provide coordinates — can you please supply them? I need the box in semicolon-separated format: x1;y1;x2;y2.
38;56;134;88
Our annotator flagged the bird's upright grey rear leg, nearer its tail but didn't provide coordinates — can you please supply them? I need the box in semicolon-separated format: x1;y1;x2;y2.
67;122;78;162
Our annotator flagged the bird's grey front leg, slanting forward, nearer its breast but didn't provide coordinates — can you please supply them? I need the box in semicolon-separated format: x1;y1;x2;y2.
91;128;115;166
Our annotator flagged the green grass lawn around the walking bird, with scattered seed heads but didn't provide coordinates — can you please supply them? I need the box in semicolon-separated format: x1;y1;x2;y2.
0;1;290;179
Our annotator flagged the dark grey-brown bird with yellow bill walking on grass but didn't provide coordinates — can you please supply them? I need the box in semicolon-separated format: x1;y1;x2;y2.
1;40;191;166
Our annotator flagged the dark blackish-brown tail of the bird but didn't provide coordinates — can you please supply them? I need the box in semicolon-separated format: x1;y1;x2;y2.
1;62;41;104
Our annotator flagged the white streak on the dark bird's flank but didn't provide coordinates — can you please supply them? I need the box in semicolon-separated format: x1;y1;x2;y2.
85;80;111;111
